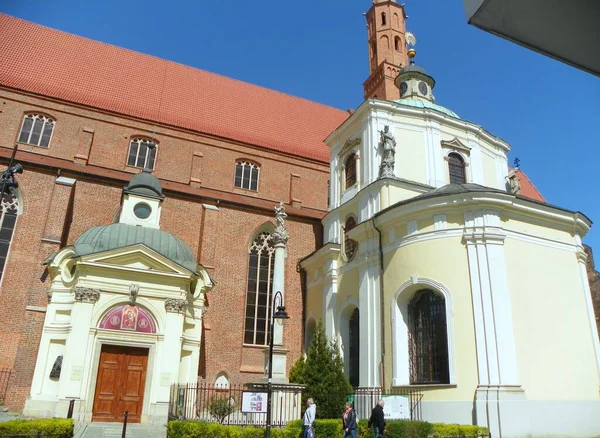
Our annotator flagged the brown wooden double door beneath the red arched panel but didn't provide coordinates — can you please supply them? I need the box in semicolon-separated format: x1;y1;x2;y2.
92;345;148;423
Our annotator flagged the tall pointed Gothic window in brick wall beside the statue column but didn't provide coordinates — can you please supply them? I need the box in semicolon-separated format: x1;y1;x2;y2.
244;232;275;345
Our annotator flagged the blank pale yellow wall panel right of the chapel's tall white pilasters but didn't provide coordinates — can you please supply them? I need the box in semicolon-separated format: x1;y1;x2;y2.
505;238;599;400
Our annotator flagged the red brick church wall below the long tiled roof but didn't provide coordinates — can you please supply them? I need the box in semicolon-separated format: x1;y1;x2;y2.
0;90;328;410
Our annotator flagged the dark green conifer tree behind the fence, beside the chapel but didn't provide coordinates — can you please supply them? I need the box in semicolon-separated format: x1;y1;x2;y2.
290;321;352;418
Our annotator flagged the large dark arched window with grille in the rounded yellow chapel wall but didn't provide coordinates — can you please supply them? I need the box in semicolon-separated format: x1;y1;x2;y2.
408;289;450;384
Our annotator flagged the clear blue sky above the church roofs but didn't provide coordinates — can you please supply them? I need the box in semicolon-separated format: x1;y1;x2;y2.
0;0;600;252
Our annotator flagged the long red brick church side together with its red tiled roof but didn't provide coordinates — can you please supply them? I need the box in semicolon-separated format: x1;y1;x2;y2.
0;15;348;416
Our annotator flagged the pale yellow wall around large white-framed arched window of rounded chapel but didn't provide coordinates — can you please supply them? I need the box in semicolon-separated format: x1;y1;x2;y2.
384;237;477;401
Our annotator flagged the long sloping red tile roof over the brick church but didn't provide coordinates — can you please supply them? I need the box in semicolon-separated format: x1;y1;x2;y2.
0;14;348;163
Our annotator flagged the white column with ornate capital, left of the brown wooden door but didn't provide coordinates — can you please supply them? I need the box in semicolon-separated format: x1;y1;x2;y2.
57;287;100;414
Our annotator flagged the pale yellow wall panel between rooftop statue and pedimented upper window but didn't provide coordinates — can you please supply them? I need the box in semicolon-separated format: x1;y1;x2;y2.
394;128;427;184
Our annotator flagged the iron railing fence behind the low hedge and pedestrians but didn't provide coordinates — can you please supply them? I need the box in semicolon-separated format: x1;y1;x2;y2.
169;382;423;427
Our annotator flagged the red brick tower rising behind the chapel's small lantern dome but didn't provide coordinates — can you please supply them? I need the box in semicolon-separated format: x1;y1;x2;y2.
363;0;408;100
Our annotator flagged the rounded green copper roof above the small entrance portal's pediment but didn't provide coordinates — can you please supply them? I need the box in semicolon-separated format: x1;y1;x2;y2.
74;224;197;272
